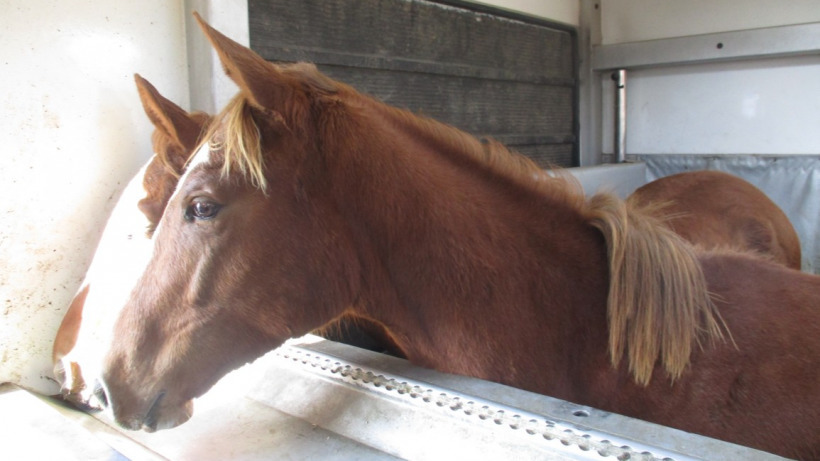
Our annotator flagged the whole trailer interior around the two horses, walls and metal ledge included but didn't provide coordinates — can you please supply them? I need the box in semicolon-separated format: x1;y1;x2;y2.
0;0;820;460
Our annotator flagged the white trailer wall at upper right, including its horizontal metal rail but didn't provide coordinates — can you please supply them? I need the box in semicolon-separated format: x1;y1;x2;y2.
596;0;820;155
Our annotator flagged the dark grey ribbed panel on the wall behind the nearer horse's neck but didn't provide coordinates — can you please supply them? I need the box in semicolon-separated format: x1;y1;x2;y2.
248;0;577;166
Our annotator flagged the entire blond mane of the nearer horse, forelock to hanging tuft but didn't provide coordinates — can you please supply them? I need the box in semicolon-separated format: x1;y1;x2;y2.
205;67;728;385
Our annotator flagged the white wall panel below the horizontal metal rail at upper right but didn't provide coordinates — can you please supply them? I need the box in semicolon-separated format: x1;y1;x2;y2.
620;56;820;155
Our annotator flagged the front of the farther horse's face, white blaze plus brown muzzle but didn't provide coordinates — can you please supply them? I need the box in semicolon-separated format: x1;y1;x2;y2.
53;161;157;408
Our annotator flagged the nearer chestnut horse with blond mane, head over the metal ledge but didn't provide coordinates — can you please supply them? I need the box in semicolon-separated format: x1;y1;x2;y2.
54;17;820;459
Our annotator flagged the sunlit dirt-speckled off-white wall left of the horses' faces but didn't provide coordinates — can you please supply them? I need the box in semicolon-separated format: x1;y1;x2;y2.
0;0;188;392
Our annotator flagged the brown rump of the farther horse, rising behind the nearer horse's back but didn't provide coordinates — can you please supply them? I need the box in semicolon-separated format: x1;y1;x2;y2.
627;171;801;270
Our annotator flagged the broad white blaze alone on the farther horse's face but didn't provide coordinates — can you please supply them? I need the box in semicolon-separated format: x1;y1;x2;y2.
62;156;158;401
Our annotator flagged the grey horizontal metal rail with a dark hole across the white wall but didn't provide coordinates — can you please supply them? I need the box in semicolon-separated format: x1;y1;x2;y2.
592;23;820;71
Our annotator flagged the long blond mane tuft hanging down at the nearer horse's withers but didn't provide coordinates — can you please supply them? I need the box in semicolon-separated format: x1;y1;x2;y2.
587;194;728;385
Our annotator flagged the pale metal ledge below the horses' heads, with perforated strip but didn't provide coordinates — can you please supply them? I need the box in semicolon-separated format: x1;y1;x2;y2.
16;337;783;461
